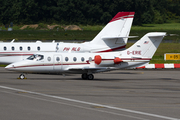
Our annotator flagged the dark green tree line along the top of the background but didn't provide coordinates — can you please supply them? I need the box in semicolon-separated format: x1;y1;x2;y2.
0;0;180;25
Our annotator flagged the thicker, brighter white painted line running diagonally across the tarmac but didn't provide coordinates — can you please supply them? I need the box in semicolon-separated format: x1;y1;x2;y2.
0;86;180;120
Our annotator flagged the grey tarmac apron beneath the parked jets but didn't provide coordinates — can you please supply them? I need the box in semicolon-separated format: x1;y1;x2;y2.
0;67;180;120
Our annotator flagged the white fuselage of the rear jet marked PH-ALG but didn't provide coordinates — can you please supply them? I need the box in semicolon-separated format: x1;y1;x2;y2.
0;42;126;64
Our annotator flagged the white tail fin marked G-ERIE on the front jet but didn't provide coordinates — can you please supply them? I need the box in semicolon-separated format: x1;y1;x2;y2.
122;32;166;59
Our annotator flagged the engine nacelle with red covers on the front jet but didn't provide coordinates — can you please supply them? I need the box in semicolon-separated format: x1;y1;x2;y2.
94;55;123;66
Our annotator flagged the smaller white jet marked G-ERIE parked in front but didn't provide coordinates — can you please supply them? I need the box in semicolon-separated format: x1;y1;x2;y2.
5;32;166;80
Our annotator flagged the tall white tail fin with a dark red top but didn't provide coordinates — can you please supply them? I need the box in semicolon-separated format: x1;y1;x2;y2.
90;12;135;49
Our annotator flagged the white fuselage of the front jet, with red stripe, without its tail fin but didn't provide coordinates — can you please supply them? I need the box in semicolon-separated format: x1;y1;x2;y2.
6;52;151;73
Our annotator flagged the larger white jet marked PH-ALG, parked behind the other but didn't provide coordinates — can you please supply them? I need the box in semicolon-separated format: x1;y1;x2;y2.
0;12;135;64
